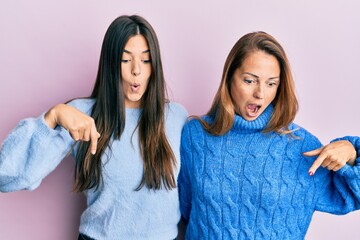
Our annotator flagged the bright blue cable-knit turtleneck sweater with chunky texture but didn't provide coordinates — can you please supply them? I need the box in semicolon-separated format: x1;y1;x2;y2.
178;106;360;240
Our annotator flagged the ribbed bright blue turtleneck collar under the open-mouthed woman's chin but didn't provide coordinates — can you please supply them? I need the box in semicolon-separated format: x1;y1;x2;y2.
231;104;274;133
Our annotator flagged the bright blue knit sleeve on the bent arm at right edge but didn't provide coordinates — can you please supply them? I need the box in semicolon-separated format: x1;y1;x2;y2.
316;137;360;215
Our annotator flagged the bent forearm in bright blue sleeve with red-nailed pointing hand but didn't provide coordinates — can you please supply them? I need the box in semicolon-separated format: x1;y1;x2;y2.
304;137;360;214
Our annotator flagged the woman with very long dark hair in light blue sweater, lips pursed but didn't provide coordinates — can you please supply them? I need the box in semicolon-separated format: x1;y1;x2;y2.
0;15;188;240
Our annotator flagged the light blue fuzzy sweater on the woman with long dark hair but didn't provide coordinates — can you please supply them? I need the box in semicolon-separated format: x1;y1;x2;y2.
0;99;188;240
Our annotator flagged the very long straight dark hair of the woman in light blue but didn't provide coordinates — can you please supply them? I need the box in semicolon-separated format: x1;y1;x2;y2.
74;15;176;192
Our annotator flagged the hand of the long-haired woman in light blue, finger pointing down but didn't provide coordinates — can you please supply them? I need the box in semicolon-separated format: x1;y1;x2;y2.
45;104;100;154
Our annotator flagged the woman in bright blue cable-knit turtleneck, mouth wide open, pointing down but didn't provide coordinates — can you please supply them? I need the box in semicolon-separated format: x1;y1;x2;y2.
178;32;360;239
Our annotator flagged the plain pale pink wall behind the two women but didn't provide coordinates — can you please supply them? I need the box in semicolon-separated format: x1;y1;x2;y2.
0;0;360;240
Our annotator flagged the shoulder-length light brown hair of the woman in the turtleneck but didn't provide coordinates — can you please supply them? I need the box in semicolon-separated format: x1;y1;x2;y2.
195;32;298;135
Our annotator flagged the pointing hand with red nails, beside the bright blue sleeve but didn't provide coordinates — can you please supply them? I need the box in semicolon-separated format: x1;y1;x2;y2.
303;140;356;176
